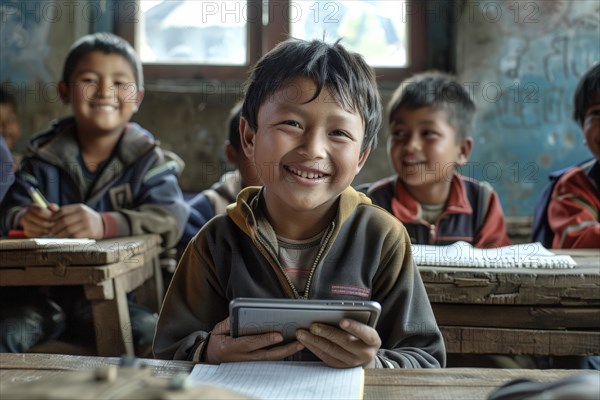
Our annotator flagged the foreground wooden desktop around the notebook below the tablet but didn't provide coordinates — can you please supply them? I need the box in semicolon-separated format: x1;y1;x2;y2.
0;353;582;400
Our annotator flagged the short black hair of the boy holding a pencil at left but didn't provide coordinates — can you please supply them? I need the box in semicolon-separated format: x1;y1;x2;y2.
62;32;144;90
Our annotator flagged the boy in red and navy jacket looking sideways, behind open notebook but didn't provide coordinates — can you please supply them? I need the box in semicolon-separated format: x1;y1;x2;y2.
367;72;510;248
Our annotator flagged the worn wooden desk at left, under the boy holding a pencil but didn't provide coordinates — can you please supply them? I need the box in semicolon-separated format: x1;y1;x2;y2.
0;235;163;356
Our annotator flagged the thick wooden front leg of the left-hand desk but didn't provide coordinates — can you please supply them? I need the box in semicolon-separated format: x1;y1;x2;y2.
85;277;135;356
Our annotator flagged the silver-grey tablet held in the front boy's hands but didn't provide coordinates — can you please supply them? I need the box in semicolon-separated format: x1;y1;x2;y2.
229;297;381;342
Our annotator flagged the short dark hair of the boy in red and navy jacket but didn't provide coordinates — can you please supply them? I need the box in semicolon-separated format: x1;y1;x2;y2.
387;71;475;142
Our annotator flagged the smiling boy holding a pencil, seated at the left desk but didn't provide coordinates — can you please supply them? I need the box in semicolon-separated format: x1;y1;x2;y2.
0;33;188;352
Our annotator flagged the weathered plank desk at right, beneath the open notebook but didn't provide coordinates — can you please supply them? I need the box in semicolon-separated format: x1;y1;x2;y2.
419;250;600;356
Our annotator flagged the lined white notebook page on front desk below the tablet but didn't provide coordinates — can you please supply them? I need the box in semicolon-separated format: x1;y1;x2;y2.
190;361;364;400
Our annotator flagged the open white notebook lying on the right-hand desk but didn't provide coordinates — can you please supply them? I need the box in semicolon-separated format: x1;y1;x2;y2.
412;241;576;268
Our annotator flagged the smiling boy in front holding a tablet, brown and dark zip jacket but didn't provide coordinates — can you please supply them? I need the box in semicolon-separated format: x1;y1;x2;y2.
154;39;445;368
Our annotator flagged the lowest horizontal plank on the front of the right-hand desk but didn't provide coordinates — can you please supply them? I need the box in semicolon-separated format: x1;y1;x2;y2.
440;326;600;356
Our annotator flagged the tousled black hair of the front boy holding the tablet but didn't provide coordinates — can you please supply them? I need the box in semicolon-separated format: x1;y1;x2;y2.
242;38;382;152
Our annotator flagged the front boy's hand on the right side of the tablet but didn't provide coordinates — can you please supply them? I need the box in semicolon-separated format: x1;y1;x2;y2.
296;319;381;368
